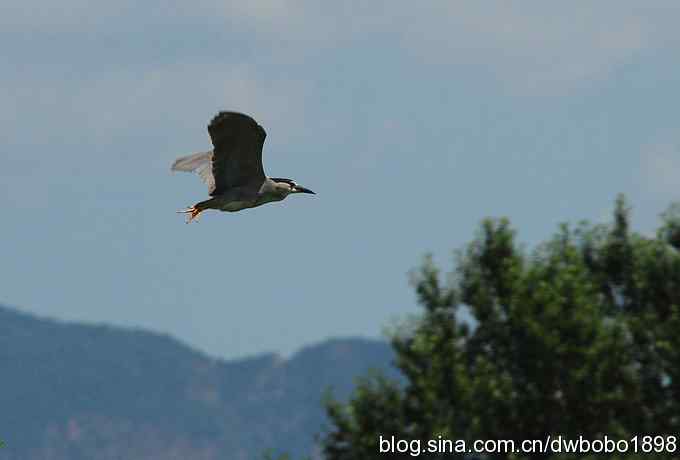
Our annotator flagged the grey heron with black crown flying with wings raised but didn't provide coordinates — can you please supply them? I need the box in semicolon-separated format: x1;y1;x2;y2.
172;112;314;223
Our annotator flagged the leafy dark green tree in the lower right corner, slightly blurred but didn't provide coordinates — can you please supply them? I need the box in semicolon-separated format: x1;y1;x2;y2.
322;197;680;460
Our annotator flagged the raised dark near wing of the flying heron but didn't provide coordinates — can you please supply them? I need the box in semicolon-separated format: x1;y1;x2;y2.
208;112;267;195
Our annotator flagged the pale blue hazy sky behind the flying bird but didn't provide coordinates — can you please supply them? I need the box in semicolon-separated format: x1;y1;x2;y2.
0;0;680;358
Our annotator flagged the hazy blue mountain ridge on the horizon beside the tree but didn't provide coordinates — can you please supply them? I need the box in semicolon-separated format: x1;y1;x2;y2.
0;307;394;460
